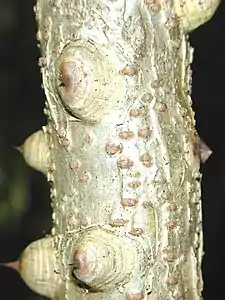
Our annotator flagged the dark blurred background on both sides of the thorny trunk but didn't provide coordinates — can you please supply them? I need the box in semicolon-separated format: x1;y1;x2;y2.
0;0;225;300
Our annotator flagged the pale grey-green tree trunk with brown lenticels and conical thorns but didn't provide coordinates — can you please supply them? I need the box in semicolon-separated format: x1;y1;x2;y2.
20;0;219;300
